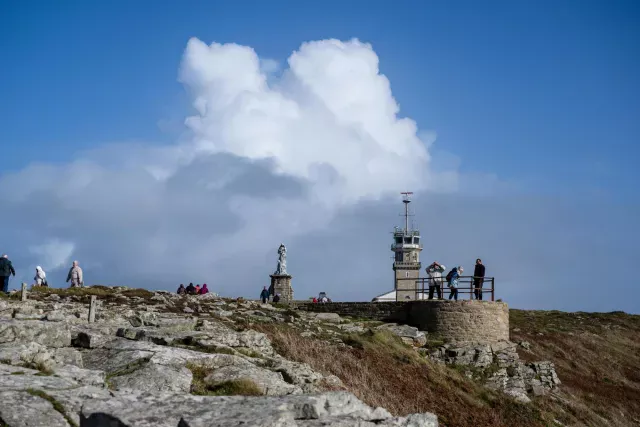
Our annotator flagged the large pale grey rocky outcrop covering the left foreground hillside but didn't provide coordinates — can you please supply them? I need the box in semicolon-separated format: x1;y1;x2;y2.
0;288;438;427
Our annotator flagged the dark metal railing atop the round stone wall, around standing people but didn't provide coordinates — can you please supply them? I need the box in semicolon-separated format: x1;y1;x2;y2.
396;275;495;301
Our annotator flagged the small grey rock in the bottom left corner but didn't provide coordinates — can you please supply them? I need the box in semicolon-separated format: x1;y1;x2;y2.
0;391;69;427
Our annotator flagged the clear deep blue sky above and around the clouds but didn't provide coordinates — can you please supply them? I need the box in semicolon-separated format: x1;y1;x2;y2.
0;1;640;311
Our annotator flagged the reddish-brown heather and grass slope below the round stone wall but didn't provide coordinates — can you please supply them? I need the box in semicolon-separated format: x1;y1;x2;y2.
261;310;640;427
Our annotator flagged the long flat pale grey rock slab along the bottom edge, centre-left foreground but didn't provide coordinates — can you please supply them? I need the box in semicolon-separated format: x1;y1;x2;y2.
81;392;438;427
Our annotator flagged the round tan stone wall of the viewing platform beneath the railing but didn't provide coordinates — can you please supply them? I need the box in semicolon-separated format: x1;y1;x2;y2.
407;300;509;342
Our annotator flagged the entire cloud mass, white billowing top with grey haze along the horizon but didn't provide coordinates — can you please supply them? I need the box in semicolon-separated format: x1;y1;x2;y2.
0;39;637;311
